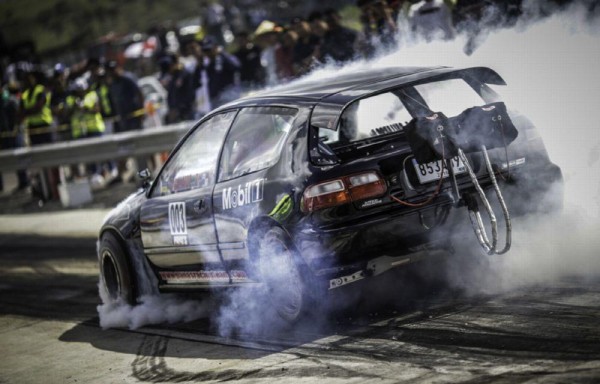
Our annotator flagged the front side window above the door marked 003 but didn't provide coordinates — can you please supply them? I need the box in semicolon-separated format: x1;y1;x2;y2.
151;112;236;197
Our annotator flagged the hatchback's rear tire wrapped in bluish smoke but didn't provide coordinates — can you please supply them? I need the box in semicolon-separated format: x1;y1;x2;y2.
257;227;308;324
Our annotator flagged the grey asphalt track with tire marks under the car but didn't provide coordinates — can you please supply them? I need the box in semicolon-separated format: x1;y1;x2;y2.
0;234;600;383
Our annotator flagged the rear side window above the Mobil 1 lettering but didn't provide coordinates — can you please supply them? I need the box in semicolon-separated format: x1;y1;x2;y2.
219;107;298;181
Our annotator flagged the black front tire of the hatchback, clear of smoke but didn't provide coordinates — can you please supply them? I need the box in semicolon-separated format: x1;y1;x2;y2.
99;232;135;305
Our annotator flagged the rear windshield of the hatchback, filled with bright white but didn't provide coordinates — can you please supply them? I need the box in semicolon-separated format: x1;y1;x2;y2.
319;79;485;146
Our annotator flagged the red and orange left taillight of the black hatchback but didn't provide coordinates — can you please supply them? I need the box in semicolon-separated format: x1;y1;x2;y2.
302;172;387;212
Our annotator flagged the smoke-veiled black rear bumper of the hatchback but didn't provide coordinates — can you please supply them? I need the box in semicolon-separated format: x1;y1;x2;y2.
293;162;563;288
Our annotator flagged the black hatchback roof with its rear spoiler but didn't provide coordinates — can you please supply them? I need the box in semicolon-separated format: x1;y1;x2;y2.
218;67;505;128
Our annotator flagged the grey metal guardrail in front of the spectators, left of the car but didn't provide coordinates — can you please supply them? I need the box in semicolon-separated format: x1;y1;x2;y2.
0;121;194;171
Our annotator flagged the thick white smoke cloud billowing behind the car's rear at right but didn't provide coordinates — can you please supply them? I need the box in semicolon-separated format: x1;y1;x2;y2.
408;3;600;292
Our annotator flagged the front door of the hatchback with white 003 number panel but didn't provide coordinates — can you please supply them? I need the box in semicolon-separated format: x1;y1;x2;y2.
140;112;235;269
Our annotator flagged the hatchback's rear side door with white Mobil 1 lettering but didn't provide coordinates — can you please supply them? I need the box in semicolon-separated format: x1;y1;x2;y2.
213;107;298;269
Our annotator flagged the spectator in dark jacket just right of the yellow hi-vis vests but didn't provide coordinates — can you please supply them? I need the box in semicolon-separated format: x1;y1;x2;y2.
106;61;144;132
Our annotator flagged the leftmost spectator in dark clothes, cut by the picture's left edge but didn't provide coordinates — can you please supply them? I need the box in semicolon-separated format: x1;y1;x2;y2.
0;82;29;191
